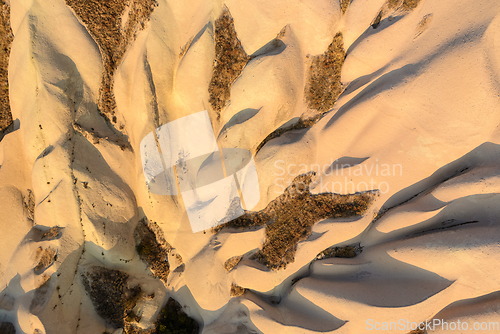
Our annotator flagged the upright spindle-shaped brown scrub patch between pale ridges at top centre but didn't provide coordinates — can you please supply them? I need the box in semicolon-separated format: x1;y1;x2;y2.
208;8;250;118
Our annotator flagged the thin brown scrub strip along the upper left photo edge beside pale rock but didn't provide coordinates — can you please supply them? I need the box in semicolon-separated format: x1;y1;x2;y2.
0;0;14;131
